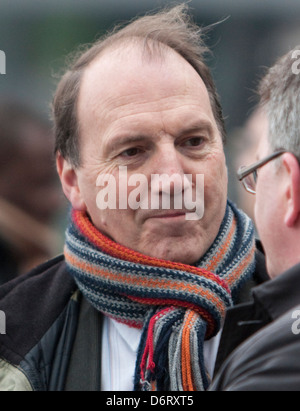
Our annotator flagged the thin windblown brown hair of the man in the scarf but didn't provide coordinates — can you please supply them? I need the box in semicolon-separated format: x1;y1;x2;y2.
52;4;226;167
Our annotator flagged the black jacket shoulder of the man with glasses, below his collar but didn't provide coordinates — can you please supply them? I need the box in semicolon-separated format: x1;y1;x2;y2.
210;306;300;391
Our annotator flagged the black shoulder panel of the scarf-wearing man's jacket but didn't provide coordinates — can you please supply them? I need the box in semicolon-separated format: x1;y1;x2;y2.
0;255;77;364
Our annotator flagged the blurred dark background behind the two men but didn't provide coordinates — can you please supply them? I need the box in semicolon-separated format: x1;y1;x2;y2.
0;0;300;283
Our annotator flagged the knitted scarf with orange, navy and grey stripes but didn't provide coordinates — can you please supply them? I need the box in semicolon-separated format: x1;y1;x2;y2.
65;202;255;391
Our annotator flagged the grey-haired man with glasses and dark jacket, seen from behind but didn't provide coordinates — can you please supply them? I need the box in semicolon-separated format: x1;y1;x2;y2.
212;47;300;391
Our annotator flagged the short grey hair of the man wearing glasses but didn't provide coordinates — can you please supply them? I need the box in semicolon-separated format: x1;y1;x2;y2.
258;46;300;162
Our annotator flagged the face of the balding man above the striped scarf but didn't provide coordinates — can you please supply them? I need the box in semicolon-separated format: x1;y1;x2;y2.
69;47;227;264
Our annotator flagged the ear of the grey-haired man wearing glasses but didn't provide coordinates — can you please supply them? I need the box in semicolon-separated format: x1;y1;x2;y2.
282;153;300;227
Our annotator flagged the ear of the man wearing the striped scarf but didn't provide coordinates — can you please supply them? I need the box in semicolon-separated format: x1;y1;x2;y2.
56;153;86;211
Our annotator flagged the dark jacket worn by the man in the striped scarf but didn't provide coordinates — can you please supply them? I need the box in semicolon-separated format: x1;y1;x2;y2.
0;248;266;391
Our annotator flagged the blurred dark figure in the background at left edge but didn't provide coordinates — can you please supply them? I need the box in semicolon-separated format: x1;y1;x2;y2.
0;99;63;284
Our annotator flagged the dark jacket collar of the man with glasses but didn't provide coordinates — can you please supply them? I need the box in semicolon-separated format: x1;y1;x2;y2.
252;264;300;320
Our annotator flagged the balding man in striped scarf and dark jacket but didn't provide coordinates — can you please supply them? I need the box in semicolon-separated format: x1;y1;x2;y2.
0;6;264;391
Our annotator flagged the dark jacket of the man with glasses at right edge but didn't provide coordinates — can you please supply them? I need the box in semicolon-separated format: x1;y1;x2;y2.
210;264;300;391
